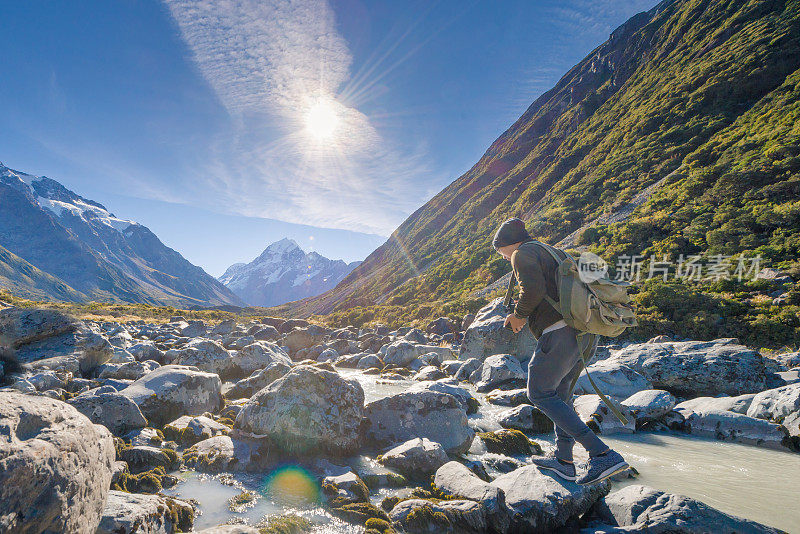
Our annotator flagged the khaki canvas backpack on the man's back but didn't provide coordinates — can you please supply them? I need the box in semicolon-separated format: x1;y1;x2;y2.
512;240;637;337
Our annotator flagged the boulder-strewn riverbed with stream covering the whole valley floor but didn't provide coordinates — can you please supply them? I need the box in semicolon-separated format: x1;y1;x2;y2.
0;302;800;534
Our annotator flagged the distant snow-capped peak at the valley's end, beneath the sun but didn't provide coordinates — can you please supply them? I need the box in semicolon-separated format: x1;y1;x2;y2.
219;239;361;306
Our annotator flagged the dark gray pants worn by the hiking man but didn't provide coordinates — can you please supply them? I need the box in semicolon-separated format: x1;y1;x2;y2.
528;326;608;462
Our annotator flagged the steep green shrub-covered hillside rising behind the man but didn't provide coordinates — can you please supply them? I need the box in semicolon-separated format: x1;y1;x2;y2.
277;0;800;346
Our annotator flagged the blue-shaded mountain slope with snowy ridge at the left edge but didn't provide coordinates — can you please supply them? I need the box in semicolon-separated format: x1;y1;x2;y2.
0;163;244;306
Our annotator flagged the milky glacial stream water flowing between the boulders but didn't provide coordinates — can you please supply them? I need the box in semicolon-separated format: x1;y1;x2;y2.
165;369;800;533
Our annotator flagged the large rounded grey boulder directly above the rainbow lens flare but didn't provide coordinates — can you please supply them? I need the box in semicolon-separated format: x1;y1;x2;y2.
236;365;364;453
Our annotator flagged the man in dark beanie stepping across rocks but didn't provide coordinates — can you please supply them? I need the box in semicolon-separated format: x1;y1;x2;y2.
492;218;629;484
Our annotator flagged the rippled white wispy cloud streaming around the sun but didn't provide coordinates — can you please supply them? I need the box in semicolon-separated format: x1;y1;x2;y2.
165;0;429;235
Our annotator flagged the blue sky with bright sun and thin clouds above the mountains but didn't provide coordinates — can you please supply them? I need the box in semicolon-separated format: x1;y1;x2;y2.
0;0;656;276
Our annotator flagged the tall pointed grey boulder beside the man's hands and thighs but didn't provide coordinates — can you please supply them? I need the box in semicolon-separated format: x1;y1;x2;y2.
458;298;536;362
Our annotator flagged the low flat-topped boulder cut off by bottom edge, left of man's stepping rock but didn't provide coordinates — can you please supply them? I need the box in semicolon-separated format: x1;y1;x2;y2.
389;499;487;534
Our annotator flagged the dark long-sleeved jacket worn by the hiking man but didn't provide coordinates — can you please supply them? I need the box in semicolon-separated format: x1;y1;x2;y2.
511;241;563;338
